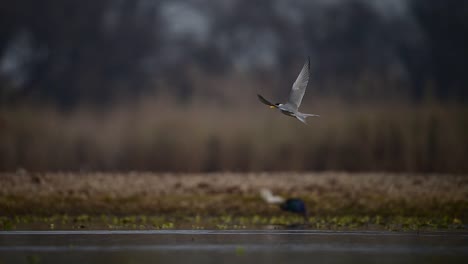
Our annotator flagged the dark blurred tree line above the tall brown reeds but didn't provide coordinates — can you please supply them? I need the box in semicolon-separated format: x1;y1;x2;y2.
0;0;468;108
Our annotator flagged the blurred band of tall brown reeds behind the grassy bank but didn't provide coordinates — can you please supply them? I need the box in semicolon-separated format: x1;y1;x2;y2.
0;96;468;173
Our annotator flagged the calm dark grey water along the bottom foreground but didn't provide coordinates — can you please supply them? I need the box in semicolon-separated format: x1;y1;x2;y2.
0;230;468;264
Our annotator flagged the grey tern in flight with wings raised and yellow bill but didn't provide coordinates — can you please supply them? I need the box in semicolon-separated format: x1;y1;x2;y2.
257;57;319;124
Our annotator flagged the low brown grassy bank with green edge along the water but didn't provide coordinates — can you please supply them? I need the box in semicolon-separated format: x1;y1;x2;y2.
0;171;468;228
